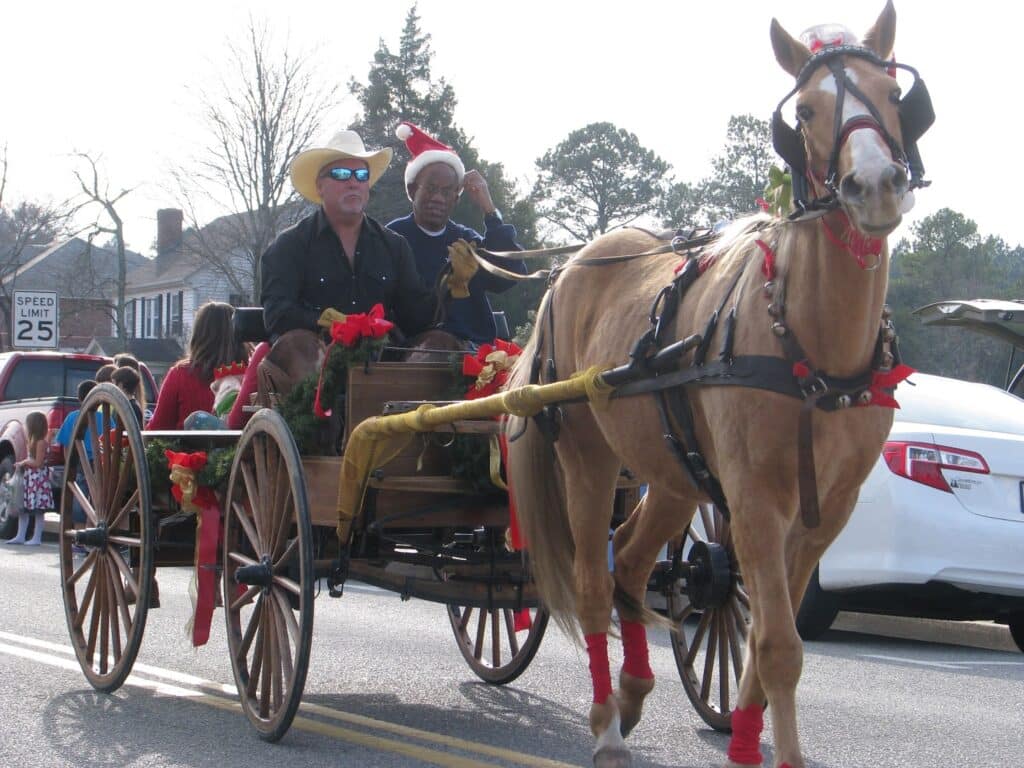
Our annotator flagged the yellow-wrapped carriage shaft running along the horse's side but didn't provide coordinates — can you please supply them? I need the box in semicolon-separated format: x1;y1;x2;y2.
338;367;612;545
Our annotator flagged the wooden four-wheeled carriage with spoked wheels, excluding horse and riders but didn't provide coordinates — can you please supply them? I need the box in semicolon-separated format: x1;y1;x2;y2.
59;310;745;740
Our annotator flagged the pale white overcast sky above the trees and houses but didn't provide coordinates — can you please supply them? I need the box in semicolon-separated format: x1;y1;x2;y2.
0;0;1024;259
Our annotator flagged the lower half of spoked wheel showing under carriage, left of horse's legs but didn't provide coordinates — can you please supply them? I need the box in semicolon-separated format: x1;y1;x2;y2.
447;605;548;685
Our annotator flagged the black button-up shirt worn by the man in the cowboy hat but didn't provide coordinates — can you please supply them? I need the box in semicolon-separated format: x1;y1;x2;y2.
260;208;437;337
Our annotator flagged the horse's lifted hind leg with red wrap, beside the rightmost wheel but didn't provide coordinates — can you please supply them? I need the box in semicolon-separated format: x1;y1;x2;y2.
613;486;692;736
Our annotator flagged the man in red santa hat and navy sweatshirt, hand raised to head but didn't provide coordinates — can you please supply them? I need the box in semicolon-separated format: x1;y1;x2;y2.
388;122;526;344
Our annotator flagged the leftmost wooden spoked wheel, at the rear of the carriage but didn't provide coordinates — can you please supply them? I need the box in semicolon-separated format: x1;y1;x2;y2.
59;384;154;693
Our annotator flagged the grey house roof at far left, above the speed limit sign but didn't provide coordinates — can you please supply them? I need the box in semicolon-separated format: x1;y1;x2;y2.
0;237;145;299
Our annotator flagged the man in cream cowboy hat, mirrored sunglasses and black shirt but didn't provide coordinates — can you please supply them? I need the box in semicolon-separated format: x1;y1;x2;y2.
260;131;436;339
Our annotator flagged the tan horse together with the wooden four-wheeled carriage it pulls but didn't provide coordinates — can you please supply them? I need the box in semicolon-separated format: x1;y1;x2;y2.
60;3;934;768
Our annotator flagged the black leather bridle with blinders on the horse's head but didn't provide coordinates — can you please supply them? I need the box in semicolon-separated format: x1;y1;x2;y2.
771;45;935;219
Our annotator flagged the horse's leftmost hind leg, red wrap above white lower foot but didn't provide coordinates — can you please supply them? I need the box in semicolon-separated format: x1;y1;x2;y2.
557;438;632;768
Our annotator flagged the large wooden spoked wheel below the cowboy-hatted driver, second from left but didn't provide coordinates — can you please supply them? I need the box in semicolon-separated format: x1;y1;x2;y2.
223;409;314;741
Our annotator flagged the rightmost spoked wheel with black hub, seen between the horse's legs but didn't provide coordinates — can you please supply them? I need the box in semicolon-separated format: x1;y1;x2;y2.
669;504;751;732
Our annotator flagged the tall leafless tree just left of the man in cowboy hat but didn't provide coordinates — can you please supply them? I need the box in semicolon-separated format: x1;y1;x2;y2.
171;18;337;300
